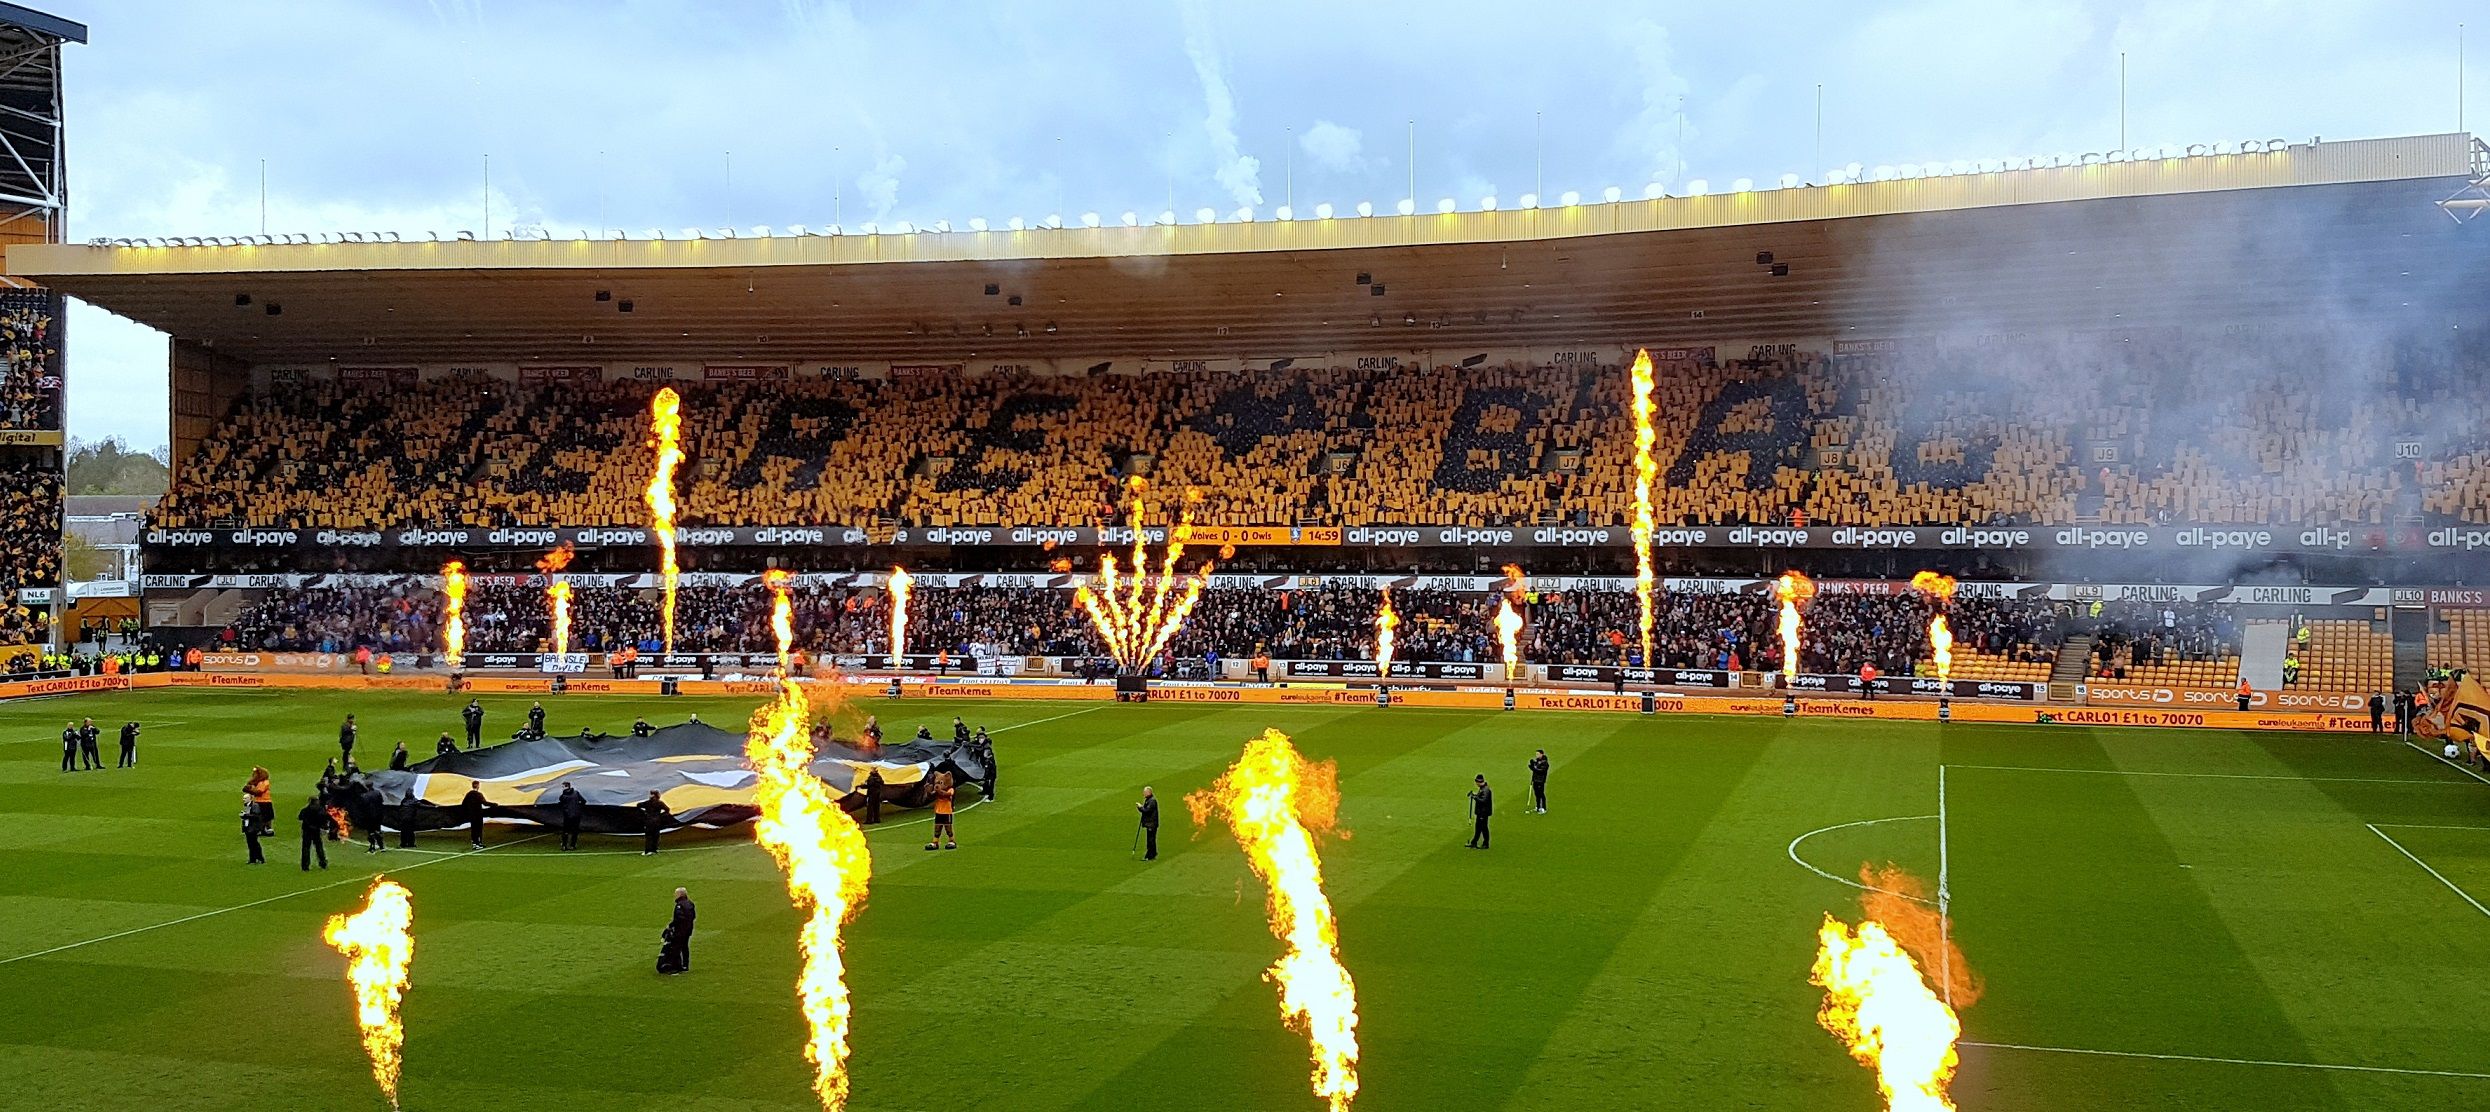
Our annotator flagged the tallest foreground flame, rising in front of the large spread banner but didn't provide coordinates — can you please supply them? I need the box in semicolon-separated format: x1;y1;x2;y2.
745;570;874;1112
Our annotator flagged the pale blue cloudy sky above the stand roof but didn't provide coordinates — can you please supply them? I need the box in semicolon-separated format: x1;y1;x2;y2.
35;0;2490;445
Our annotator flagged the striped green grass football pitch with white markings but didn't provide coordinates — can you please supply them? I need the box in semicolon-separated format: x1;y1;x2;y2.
0;692;2490;1112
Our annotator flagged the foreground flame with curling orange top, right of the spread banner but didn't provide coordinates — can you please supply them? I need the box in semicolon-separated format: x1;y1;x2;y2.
1185;729;1357;1112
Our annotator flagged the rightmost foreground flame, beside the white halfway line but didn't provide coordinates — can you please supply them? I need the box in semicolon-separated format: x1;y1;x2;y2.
1808;915;1962;1112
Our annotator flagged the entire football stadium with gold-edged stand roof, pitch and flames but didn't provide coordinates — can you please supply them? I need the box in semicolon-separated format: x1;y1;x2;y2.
0;5;2490;1112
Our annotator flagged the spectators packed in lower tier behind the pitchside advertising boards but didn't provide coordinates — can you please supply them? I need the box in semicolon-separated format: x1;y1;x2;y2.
204;582;2071;674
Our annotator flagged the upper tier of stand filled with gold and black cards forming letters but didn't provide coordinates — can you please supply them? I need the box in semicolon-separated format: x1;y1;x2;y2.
154;338;2490;527
